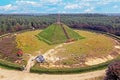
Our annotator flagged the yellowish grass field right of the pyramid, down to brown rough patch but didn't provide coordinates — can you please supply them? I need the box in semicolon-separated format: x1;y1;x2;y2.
57;30;116;65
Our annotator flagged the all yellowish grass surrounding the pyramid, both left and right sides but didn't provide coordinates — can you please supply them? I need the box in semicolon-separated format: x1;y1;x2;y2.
16;30;116;64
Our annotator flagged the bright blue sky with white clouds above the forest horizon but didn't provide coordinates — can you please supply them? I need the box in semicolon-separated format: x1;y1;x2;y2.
0;0;120;14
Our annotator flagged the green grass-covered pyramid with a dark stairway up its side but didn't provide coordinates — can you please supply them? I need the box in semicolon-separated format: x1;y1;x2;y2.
37;23;83;44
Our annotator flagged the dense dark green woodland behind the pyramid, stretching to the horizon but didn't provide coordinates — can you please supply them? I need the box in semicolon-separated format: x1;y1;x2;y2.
0;14;120;36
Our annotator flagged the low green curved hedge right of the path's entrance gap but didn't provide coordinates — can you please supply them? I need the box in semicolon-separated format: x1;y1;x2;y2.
31;57;120;74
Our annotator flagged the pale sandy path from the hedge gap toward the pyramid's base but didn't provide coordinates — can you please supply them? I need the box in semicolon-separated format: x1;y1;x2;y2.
23;43;72;72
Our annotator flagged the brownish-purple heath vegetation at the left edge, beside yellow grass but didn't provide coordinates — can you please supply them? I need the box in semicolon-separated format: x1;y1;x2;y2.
0;35;18;61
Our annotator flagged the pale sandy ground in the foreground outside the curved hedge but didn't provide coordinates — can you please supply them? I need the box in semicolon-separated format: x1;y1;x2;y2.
0;68;105;80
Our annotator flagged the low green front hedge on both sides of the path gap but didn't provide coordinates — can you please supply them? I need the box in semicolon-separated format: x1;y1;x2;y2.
0;52;120;74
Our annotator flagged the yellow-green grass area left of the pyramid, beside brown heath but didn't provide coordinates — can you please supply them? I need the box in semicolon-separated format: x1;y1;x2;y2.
16;30;56;55
